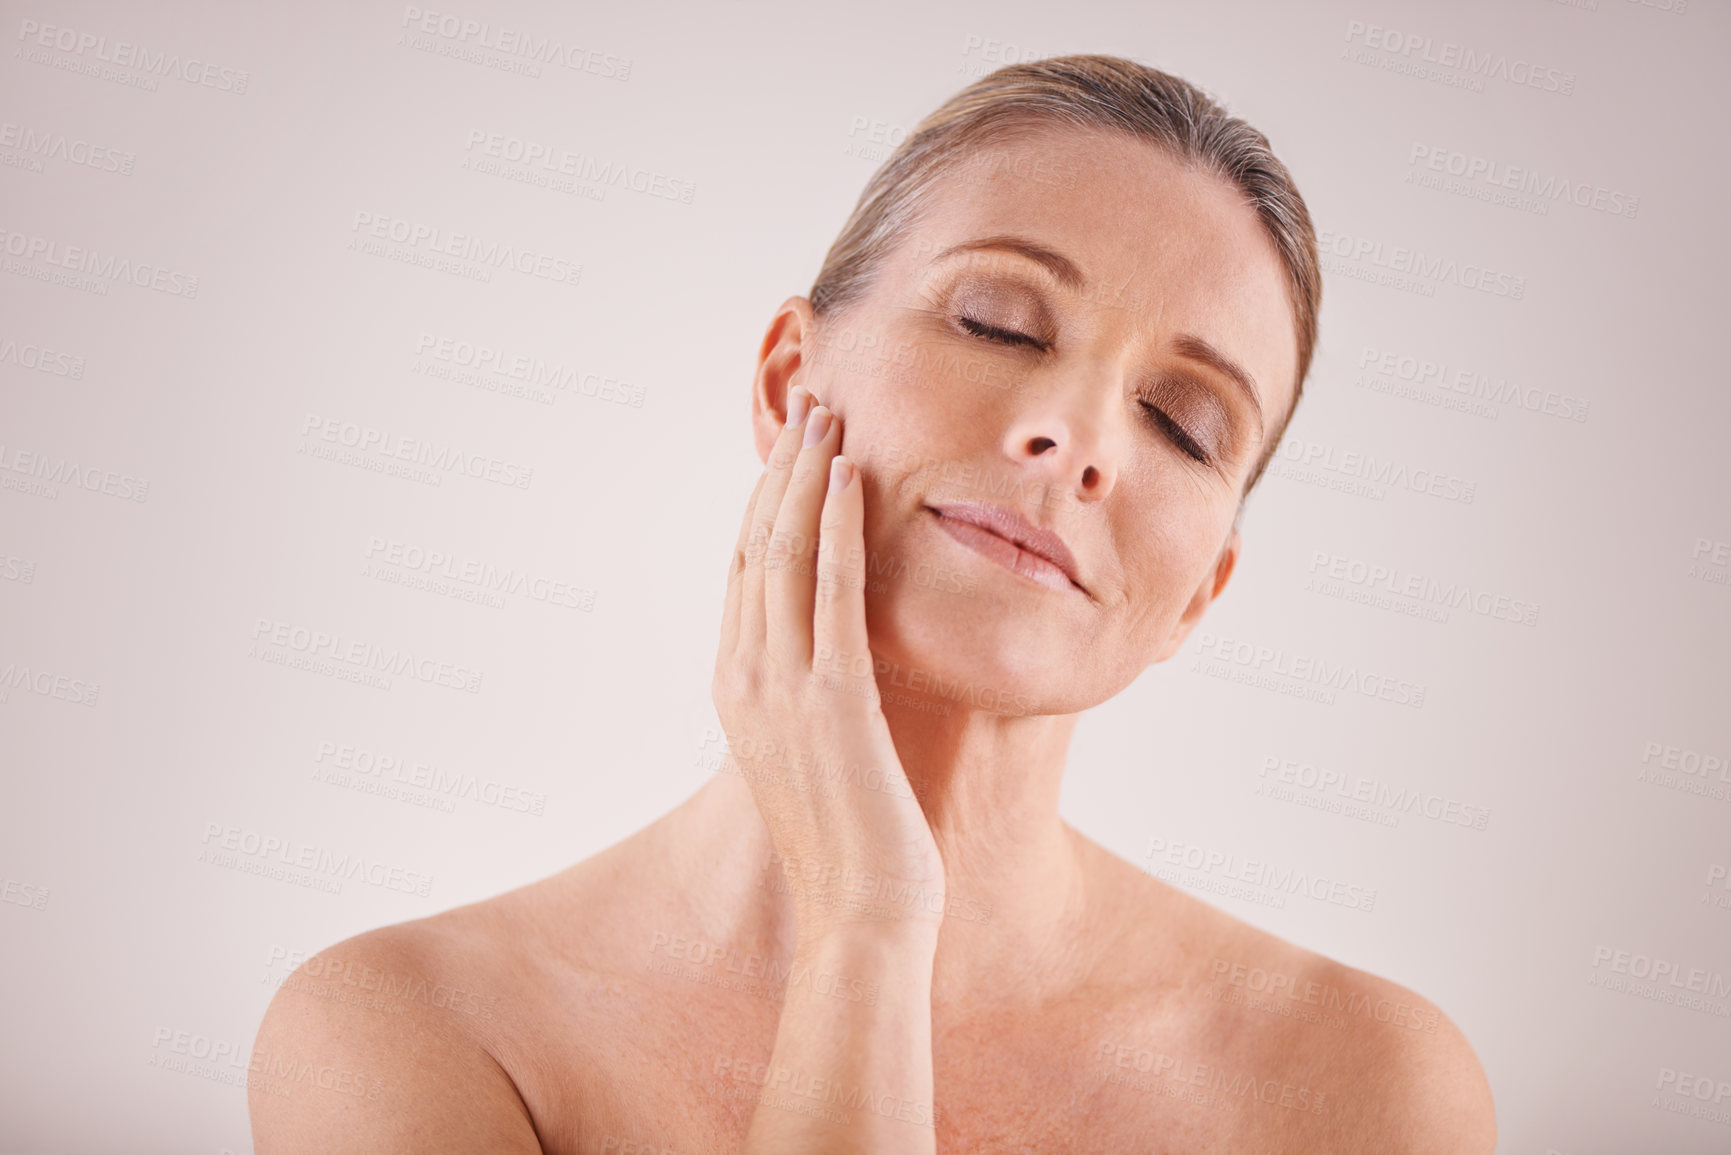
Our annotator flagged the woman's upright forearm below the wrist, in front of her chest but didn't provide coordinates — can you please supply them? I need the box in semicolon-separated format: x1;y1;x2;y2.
736;926;936;1155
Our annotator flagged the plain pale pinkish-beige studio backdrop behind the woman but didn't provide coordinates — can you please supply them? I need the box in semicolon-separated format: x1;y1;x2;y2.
0;0;1731;1155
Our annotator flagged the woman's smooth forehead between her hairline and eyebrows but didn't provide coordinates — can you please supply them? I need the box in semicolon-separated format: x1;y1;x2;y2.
893;126;1298;414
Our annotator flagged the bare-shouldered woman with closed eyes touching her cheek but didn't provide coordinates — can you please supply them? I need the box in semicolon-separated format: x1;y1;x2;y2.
249;55;1496;1155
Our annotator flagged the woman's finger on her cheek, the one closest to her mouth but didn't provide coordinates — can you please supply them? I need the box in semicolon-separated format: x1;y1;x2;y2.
812;454;878;700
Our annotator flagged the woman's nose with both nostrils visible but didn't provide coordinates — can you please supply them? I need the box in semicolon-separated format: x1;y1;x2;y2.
1004;372;1123;502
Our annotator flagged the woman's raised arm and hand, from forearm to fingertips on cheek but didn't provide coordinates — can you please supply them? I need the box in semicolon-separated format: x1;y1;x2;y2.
713;386;943;1155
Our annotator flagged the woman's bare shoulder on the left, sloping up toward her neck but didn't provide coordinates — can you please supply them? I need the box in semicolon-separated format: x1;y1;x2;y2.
248;820;695;1155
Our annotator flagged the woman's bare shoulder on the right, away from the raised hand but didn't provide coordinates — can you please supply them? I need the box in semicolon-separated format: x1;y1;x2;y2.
1091;831;1496;1155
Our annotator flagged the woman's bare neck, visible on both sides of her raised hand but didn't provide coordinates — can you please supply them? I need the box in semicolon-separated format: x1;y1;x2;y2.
665;694;1084;1006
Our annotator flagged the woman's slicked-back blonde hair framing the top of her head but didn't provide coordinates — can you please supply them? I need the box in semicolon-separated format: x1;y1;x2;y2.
808;55;1322;495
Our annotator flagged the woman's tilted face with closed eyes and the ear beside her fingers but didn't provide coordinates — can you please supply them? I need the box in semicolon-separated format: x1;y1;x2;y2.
758;130;1297;713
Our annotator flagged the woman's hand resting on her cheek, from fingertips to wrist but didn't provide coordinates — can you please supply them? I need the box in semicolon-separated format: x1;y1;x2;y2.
711;386;943;940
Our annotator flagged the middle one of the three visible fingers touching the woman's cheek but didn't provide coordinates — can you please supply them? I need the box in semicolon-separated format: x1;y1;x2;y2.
763;405;841;668
